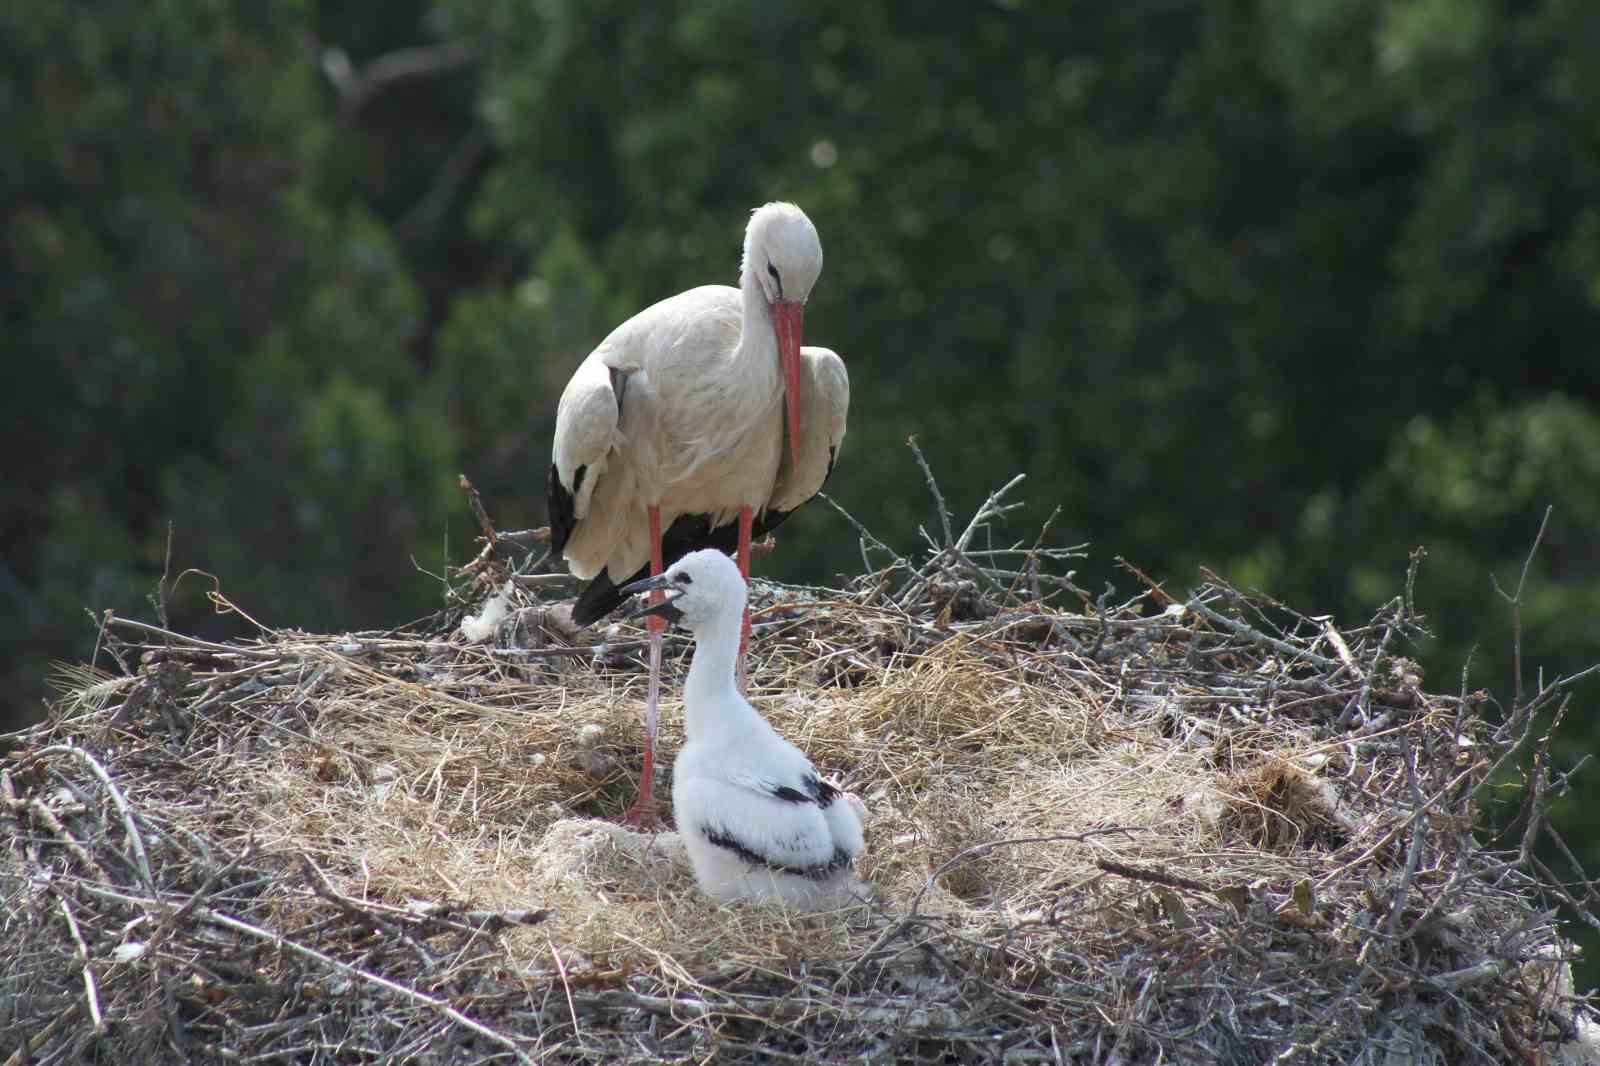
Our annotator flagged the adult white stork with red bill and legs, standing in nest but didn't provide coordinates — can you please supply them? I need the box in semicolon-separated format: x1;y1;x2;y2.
547;203;850;824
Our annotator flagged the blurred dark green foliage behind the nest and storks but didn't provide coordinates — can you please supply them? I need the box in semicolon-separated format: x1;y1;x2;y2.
0;0;1600;973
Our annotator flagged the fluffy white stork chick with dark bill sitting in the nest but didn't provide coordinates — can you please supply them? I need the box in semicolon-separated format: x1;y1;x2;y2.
624;549;862;909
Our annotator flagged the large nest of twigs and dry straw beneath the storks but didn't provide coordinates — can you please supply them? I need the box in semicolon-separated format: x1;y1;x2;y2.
0;473;1600;1066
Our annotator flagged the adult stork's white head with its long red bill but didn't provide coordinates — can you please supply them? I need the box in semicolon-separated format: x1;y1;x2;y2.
742;203;822;466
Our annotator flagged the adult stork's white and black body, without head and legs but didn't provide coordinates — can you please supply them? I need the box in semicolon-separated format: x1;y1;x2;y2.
550;285;850;614
